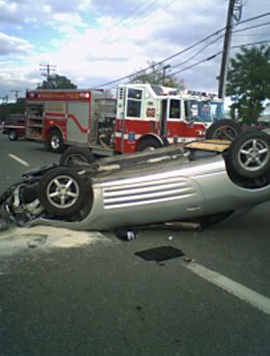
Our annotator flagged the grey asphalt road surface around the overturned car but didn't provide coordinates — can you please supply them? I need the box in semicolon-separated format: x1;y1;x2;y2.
0;136;270;356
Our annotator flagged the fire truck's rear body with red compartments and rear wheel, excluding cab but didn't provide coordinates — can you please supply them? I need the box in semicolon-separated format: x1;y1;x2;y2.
26;90;116;152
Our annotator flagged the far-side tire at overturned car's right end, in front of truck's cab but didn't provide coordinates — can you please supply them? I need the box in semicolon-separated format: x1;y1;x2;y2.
206;119;241;141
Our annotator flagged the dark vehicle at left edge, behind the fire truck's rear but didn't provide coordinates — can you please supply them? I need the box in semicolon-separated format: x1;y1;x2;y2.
2;114;26;141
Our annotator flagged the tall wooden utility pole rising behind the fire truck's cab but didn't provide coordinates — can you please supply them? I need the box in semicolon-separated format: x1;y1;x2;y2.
218;0;243;99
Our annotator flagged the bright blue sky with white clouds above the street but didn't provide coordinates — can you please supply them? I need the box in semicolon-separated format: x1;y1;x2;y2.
0;0;270;103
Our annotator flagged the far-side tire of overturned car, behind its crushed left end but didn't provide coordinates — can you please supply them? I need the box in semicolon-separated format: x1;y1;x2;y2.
60;147;96;167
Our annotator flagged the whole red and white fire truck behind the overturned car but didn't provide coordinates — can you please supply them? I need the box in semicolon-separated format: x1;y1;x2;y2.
26;84;236;155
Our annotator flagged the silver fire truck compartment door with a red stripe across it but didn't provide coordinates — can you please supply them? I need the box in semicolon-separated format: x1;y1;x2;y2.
66;102;90;143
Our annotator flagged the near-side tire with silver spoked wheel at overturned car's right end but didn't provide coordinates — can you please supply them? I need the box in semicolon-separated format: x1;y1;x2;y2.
228;130;270;178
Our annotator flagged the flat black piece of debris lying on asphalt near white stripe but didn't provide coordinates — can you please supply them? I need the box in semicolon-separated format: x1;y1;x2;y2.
135;246;185;262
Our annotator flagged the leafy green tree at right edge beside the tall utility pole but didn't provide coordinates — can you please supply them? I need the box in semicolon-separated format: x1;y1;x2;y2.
226;46;270;124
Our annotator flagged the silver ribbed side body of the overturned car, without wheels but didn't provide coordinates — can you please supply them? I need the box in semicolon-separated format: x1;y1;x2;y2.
31;155;270;230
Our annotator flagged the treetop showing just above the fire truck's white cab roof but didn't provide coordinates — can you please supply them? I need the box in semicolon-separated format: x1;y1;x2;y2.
130;61;185;89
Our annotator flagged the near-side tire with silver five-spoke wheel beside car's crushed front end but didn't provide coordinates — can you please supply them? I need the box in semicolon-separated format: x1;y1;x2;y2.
38;167;87;217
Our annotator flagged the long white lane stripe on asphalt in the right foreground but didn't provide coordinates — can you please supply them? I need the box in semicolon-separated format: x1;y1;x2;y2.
184;262;270;315
